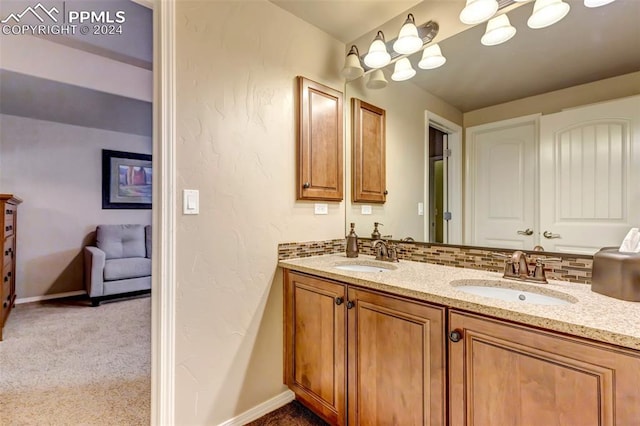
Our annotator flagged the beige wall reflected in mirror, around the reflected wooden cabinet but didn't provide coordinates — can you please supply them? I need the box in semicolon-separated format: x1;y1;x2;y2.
345;76;462;241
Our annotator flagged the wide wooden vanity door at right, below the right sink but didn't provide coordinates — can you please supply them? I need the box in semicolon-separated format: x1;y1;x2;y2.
449;311;640;426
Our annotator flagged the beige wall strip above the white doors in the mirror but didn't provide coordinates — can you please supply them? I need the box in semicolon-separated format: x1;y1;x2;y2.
464;71;640;127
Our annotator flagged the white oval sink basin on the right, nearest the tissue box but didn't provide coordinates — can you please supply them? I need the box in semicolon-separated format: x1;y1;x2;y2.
451;280;578;305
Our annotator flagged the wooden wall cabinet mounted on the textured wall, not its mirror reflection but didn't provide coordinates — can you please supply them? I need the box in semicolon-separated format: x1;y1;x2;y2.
296;77;343;201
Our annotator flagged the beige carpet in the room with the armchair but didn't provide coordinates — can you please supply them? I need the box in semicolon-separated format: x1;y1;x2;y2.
0;296;151;426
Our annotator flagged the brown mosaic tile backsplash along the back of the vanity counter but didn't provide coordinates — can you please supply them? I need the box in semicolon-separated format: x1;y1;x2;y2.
278;238;593;284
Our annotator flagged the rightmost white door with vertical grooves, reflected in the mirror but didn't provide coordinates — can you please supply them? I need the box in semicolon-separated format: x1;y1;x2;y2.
540;96;640;254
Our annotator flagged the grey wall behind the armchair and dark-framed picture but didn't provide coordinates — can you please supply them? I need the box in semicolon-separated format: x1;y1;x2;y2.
0;115;151;298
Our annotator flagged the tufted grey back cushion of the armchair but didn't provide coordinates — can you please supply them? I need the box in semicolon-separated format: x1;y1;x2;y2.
96;225;146;259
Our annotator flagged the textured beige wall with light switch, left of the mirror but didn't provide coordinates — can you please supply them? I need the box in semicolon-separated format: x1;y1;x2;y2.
176;1;345;425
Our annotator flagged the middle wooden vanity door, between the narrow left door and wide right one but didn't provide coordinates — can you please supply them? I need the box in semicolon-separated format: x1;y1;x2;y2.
348;288;446;426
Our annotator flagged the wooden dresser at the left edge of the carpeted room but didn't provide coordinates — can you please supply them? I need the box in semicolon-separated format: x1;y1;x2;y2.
0;194;22;340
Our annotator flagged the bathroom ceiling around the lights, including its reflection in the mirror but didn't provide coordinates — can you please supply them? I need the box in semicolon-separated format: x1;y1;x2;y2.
272;0;640;112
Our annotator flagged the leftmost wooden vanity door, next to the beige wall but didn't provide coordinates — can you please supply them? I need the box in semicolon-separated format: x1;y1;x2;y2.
284;270;347;425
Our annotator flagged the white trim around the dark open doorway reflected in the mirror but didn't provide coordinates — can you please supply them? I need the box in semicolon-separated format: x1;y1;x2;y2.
424;111;464;244
